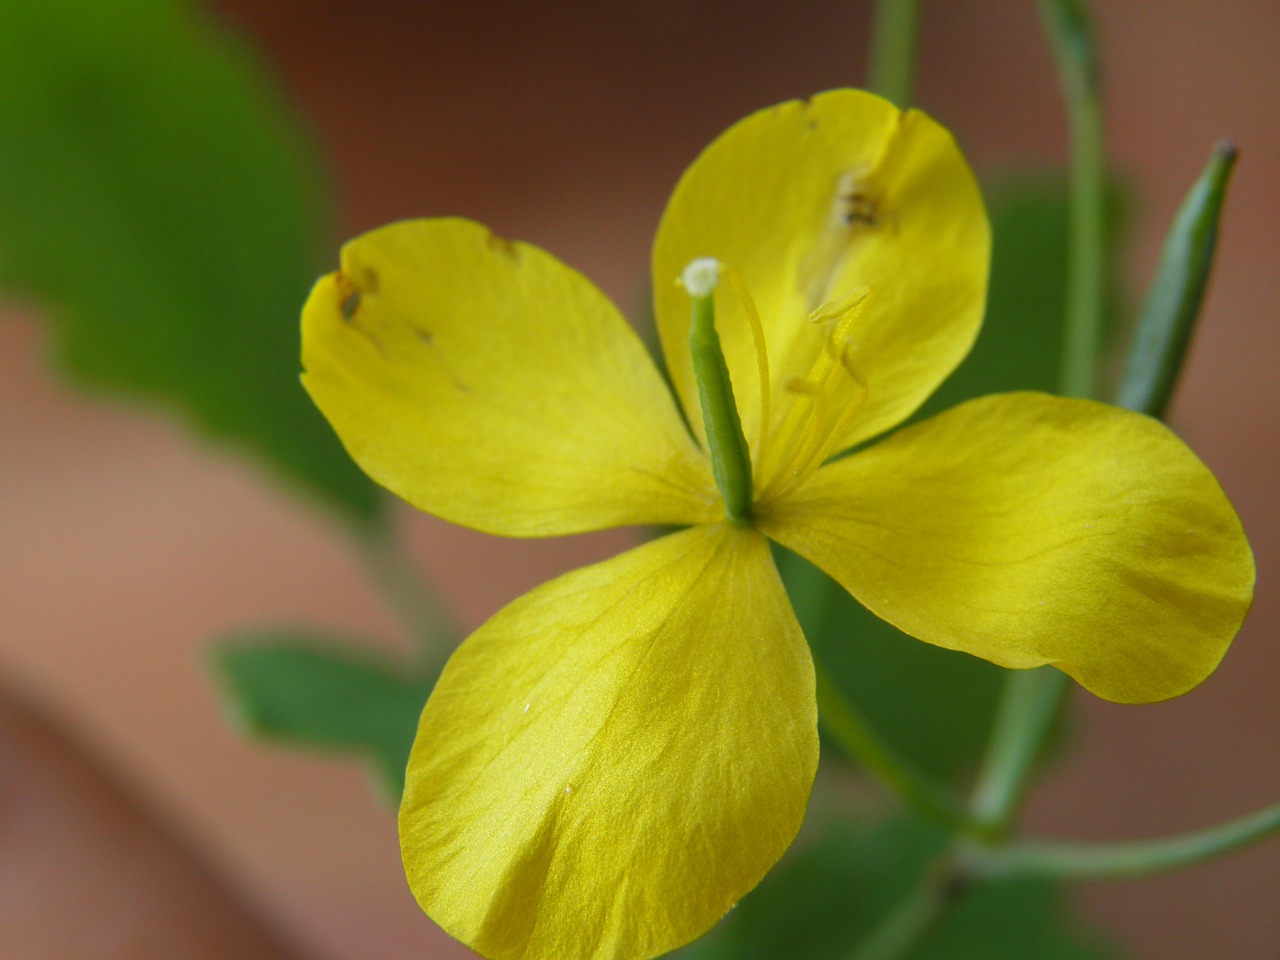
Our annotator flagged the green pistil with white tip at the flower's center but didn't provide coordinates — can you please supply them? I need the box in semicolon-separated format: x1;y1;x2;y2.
681;257;751;522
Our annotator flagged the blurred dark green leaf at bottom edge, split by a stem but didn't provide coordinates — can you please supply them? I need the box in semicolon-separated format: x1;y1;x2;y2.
676;820;1115;960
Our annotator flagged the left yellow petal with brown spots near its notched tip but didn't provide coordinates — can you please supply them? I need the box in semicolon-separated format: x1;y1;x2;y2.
302;220;721;536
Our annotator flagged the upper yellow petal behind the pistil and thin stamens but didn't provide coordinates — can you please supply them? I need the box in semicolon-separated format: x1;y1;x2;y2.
653;90;991;489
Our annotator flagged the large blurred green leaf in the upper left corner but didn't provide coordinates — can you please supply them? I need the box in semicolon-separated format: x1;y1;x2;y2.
0;0;378;520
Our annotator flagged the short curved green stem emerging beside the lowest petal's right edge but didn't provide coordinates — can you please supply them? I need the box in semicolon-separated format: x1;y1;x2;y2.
814;660;974;833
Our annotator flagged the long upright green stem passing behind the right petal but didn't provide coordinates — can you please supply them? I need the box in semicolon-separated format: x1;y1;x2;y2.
970;0;1106;838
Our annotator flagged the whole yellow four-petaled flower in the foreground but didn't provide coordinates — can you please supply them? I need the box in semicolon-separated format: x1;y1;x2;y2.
302;91;1253;960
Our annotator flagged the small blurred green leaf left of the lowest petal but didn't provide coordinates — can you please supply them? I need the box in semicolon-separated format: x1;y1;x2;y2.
212;631;435;803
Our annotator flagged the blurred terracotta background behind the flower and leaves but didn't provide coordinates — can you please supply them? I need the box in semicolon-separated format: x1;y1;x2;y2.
0;0;1280;960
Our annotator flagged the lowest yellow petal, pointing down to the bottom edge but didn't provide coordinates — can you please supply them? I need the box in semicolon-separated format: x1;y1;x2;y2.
401;526;818;960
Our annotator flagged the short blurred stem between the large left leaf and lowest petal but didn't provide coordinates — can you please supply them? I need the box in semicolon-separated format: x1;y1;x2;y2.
356;509;458;660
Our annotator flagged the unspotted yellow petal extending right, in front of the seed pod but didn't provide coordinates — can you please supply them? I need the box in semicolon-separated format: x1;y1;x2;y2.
760;393;1253;703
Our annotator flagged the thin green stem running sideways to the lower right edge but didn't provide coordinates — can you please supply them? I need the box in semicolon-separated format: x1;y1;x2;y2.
965;804;1280;881
